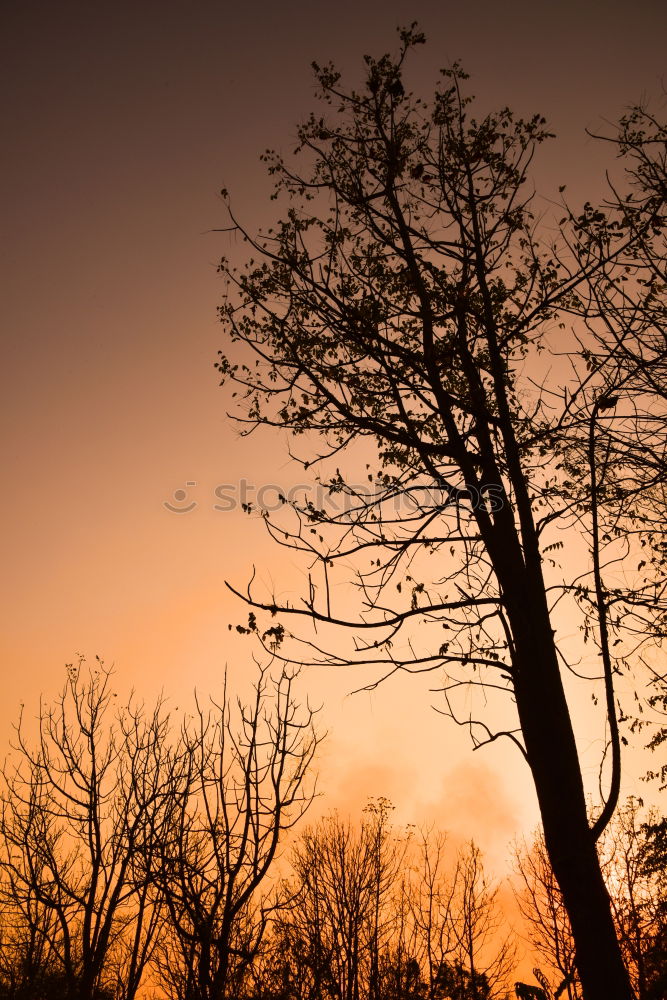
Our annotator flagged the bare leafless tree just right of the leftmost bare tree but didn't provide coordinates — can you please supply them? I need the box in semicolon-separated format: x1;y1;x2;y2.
157;669;319;1000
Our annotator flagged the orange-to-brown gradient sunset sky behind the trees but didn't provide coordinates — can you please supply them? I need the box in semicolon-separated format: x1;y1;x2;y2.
0;0;667;888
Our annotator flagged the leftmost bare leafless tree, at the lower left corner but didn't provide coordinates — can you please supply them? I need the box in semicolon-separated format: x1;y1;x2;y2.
0;661;173;1000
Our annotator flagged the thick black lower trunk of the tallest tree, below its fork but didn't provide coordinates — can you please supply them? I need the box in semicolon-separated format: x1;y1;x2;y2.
514;594;634;1000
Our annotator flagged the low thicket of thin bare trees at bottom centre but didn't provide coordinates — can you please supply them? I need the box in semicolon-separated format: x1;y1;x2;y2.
264;798;514;1000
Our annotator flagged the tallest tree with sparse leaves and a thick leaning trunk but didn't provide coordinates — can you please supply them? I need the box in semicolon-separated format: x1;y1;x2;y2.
218;26;655;1000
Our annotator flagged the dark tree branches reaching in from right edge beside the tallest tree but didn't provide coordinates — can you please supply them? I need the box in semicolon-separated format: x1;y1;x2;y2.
570;106;667;796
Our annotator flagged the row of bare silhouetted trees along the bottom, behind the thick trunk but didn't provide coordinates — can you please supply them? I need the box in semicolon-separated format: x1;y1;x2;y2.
0;662;667;1000
